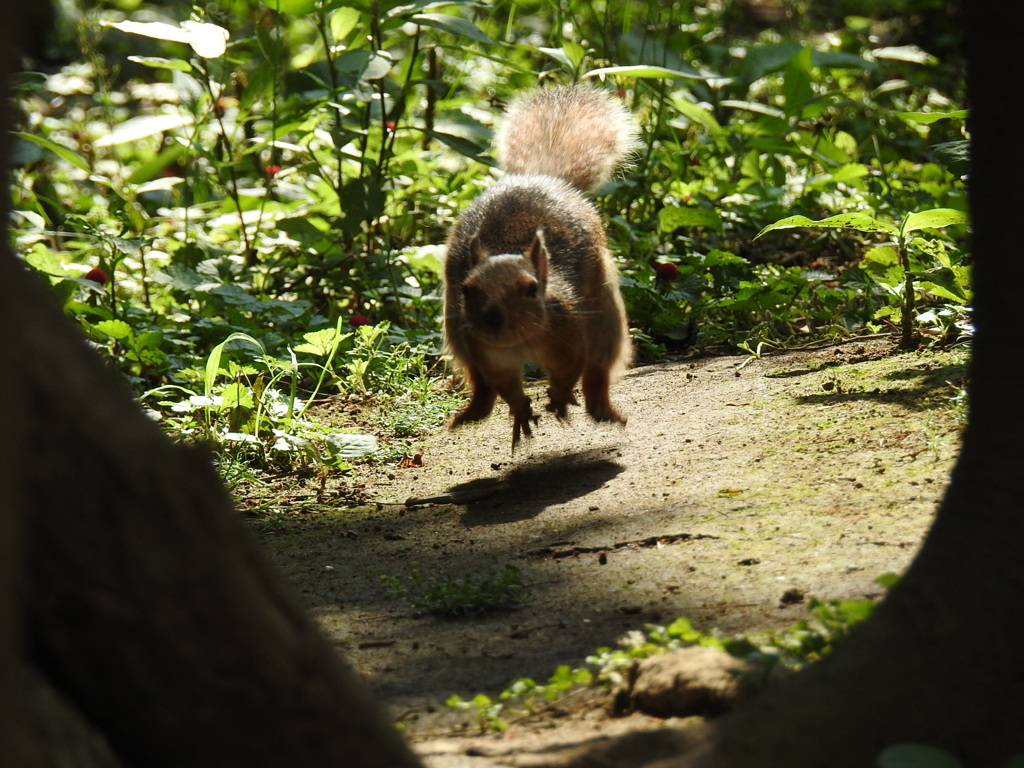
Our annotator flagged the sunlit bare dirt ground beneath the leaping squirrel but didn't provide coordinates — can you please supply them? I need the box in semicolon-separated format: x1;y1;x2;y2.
251;339;965;766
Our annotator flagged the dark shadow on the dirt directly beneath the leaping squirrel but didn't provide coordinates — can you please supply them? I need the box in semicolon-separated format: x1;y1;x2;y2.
450;450;625;527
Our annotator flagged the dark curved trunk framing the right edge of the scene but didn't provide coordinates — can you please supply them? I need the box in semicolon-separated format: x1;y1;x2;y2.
643;0;1024;768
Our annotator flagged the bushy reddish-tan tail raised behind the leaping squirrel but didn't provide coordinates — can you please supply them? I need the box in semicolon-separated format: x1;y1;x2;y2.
496;85;638;191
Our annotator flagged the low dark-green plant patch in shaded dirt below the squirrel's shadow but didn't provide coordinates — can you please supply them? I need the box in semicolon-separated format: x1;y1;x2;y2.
381;563;529;617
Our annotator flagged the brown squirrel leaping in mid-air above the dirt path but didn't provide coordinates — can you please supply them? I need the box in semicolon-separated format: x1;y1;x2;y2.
443;85;638;451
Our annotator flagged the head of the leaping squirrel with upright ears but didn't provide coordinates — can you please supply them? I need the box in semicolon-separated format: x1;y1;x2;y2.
461;230;548;347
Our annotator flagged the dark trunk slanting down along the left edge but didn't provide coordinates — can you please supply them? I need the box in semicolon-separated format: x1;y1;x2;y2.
0;1;418;768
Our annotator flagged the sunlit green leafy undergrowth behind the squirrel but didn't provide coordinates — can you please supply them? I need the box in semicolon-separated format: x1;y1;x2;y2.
11;0;971;477
